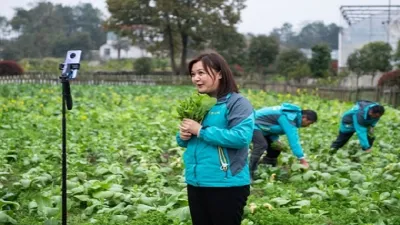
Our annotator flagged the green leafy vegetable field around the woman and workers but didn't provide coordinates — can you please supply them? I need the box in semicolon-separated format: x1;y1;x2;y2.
0;85;400;225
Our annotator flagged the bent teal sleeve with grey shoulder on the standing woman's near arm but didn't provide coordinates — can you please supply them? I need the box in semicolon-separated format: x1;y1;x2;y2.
198;98;254;149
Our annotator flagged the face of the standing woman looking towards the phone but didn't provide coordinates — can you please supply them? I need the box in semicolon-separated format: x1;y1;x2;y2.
190;61;221;97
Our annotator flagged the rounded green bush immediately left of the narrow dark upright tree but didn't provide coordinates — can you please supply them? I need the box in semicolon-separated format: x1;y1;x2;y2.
277;49;311;81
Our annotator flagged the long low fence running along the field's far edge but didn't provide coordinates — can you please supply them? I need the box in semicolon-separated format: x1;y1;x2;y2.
0;73;400;107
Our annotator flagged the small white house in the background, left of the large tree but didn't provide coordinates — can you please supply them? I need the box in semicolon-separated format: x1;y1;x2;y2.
99;32;152;60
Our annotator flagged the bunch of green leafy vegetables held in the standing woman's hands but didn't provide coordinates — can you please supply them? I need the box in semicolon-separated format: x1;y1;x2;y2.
177;93;217;122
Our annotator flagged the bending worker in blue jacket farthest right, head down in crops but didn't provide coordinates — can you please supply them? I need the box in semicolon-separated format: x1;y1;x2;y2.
331;100;385;153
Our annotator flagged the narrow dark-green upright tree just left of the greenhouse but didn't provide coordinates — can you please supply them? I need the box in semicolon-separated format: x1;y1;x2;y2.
310;44;331;77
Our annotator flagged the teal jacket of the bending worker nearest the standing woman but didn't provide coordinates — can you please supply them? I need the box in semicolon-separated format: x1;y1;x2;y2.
255;103;304;159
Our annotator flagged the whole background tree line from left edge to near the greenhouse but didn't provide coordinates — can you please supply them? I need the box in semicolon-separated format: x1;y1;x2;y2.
0;0;340;77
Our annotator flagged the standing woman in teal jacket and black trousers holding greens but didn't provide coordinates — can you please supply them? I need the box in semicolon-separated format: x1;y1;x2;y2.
177;53;254;225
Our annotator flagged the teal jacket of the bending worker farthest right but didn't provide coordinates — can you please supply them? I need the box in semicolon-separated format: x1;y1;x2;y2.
340;101;379;150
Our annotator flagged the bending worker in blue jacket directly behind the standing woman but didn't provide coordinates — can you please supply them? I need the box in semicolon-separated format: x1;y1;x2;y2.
249;103;318;177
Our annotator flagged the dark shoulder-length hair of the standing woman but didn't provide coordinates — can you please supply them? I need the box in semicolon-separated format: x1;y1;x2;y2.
188;52;239;98
